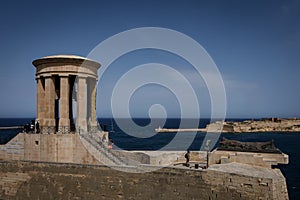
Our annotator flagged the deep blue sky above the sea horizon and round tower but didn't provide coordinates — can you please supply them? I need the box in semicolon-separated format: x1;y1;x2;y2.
0;0;300;118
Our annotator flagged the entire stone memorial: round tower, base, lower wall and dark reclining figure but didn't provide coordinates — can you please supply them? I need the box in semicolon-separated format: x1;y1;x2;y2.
0;55;289;200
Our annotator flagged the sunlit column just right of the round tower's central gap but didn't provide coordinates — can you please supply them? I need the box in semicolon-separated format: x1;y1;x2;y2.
76;76;87;132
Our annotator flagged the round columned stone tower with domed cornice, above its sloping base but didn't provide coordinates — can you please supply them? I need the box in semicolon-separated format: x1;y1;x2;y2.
32;55;100;134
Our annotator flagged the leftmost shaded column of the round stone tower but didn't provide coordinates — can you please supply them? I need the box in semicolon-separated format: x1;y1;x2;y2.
36;77;45;124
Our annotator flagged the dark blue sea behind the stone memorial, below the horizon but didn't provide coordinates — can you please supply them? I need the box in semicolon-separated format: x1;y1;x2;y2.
0;118;300;200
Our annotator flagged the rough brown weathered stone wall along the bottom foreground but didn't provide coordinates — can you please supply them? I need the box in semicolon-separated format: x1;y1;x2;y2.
0;161;288;200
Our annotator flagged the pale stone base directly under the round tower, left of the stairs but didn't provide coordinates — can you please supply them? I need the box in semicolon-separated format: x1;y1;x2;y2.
0;133;101;164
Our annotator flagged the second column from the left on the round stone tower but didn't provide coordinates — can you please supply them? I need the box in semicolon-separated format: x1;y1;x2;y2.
42;76;56;133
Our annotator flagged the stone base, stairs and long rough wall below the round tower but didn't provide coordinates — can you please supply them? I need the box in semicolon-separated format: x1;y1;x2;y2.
0;133;288;200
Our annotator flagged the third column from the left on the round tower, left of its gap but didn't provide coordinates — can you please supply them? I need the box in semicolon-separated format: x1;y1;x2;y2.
58;76;70;133
